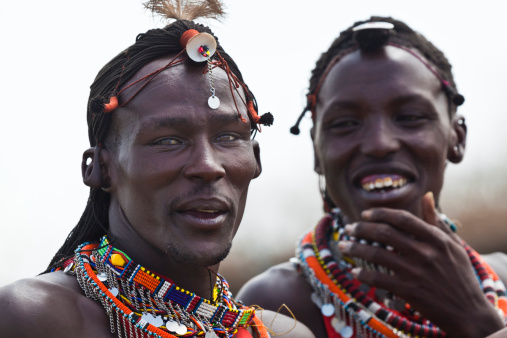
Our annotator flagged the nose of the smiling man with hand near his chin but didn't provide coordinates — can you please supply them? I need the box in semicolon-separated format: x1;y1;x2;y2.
361;120;400;158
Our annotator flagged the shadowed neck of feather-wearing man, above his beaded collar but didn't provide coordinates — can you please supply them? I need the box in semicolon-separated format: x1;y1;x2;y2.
108;201;219;299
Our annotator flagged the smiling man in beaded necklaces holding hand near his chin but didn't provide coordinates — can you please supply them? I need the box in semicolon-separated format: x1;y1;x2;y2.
238;17;507;338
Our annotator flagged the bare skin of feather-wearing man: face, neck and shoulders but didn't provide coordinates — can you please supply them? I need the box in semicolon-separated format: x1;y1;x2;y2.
0;56;311;337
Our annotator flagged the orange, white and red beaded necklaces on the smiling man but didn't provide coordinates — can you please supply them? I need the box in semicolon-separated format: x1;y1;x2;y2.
296;209;507;338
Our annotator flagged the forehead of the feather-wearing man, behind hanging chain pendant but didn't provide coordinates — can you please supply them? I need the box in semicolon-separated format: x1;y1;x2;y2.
115;56;250;129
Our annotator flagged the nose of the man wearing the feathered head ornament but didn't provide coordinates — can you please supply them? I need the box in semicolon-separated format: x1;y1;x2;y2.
184;142;225;182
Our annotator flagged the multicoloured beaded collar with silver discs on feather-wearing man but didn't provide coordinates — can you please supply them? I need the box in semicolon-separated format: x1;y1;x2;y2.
65;236;269;338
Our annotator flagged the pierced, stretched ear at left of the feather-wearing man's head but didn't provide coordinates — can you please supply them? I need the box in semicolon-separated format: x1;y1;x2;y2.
81;145;110;191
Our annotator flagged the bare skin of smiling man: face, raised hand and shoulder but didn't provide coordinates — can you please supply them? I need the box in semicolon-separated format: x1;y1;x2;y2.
238;46;505;338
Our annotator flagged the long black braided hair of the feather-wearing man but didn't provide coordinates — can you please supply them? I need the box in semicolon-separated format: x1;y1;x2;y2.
43;20;257;273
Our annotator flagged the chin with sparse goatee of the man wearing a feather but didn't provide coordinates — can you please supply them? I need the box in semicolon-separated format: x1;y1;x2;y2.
166;242;232;267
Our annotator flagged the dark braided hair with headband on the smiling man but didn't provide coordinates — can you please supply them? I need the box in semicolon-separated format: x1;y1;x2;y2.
290;16;465;135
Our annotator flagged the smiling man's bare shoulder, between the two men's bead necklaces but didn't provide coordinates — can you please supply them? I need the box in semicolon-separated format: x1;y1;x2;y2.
236;262;312;311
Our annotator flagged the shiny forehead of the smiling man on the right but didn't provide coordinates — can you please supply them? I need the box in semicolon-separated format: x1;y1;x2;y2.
317;46;445;115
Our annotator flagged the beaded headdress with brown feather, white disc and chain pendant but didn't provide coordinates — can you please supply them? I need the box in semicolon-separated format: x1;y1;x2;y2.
89;0;273;145
